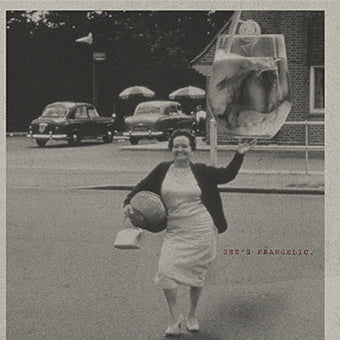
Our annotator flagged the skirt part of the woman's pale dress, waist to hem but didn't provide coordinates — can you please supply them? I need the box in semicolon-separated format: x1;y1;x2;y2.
155;213;216;289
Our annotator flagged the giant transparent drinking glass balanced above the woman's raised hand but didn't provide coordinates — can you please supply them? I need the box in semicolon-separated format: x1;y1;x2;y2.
208;34;292;139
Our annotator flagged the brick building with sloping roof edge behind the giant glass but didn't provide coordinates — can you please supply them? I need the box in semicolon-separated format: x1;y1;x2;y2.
191;11;325;145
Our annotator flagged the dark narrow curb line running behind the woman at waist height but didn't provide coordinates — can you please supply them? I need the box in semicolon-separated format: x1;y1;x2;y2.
72;185;325;195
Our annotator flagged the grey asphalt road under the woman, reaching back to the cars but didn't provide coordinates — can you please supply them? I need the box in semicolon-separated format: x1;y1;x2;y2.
7;138;324;340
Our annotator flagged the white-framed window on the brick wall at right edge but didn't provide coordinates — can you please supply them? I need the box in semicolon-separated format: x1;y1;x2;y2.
310;66;325;113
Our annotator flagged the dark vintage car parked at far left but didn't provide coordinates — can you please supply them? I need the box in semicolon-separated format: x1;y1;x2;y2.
28;102;115;147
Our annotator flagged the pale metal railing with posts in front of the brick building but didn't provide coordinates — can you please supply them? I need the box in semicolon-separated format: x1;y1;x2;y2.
210;119;325;174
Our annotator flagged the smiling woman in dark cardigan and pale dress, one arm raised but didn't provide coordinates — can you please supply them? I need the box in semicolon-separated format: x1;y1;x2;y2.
124;130;256;336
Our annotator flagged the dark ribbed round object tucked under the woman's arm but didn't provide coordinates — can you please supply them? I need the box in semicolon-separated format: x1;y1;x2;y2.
129;191;167;233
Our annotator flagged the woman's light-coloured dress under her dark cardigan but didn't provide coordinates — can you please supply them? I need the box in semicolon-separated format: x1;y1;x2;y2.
155;164;217;289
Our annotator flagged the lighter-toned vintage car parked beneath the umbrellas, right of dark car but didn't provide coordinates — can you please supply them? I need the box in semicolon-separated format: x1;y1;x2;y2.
124;100;195;144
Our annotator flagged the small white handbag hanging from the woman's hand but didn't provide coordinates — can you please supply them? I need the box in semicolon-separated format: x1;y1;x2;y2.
113;218;143;249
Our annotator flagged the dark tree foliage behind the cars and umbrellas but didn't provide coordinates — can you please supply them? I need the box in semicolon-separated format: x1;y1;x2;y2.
7;11;232;128
